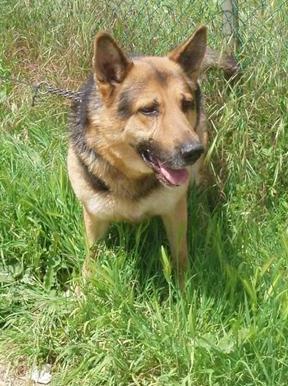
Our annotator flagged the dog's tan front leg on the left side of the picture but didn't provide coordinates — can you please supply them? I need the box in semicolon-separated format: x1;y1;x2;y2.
82;207;109;278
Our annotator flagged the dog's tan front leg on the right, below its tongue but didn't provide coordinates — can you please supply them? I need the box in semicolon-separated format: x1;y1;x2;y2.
162;193;188;288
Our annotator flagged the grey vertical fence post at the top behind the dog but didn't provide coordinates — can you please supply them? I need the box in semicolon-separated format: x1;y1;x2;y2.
221;0;239;52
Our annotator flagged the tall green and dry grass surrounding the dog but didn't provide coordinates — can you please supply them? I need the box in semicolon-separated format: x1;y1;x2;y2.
0;0;288;386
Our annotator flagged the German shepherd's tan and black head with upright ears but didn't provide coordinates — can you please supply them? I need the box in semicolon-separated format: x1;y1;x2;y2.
89;27;206;186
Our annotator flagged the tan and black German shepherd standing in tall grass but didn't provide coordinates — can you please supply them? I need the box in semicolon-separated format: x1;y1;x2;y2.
68;26;237;285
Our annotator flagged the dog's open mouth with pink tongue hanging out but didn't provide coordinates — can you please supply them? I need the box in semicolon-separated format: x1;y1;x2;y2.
140;149;189;186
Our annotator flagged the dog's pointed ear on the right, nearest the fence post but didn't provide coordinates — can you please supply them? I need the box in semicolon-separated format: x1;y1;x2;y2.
168;26;207;80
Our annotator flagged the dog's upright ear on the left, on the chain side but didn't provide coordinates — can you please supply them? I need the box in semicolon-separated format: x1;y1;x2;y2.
93;32;133;97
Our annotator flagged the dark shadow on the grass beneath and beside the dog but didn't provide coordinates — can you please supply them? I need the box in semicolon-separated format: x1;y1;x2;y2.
100;181;243;304
